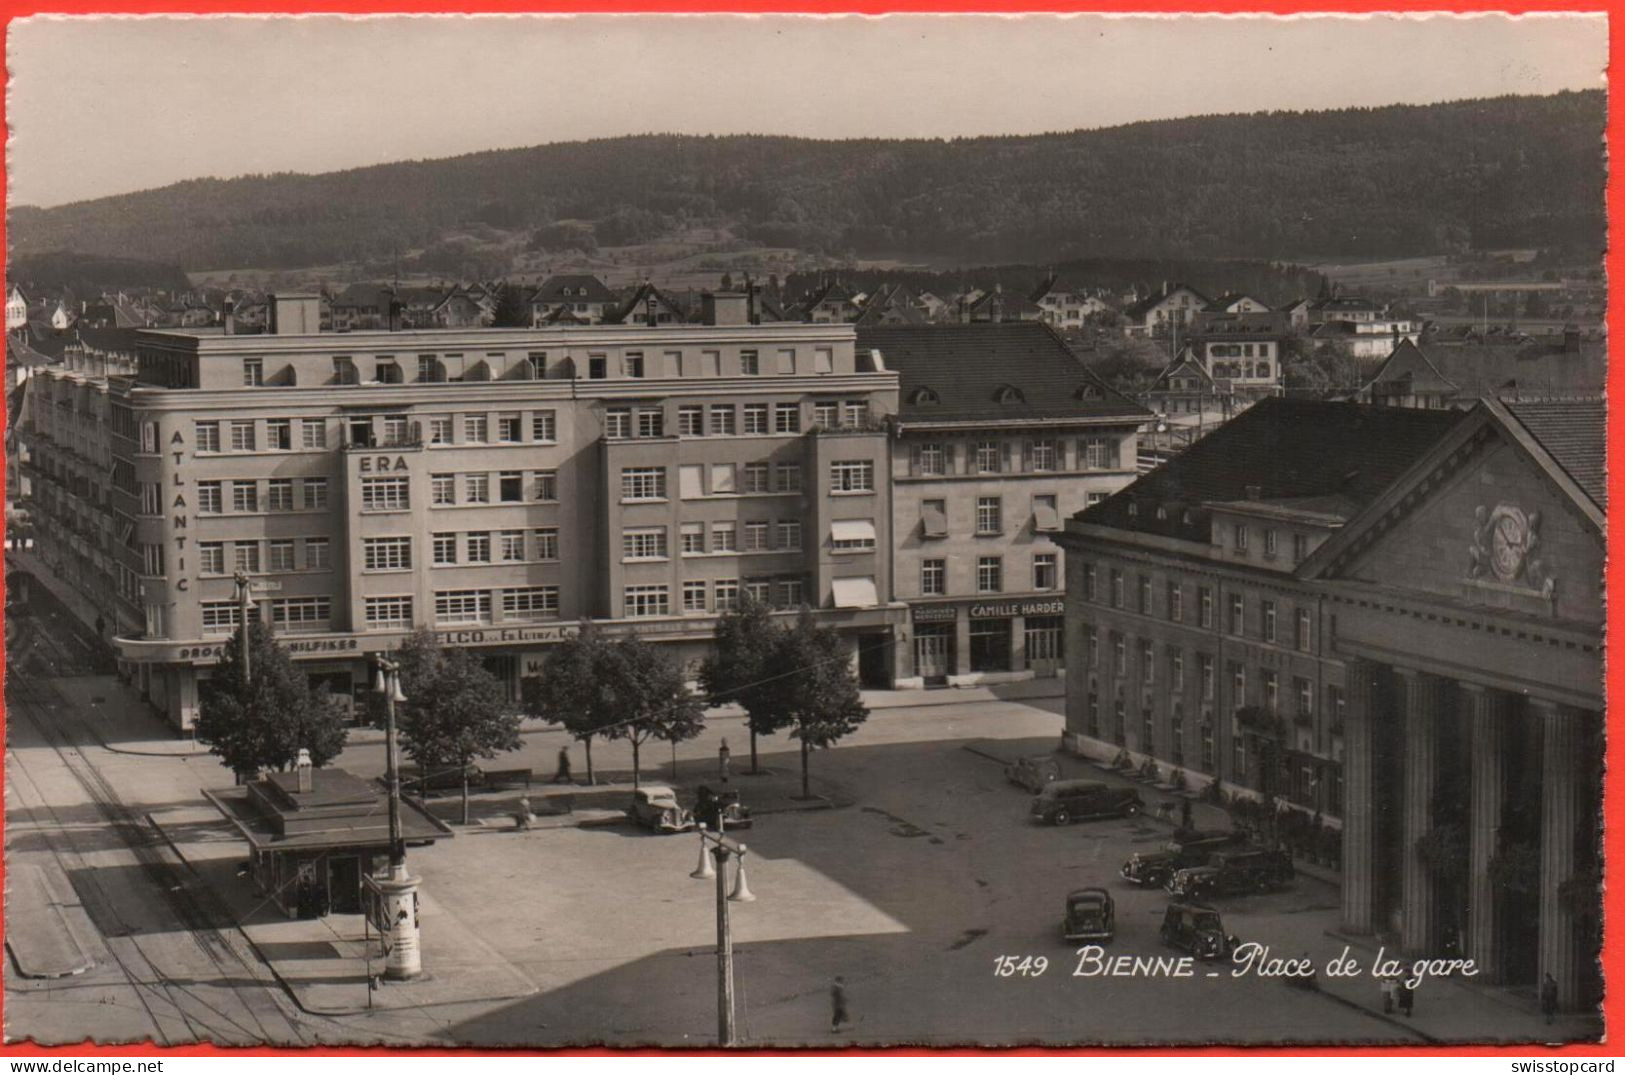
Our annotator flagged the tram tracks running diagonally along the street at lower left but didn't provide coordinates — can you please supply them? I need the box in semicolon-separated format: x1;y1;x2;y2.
7;672;314;1046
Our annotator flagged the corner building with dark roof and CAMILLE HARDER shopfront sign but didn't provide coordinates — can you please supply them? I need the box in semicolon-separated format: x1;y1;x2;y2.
858;323;1151;685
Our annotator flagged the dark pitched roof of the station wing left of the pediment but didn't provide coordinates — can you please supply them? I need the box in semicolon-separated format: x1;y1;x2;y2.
1076;398;1466;541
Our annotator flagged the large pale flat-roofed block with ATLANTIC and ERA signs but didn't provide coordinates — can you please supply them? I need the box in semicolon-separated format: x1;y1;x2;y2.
28;296;905;727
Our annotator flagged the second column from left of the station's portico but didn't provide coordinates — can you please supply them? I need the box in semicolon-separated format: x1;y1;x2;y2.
1394;667;1448;955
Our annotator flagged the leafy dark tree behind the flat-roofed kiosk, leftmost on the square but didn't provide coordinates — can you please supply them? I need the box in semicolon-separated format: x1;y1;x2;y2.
197;617;349;781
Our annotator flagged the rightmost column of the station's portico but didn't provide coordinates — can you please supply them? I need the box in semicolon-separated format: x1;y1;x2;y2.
1529;698;1584;1008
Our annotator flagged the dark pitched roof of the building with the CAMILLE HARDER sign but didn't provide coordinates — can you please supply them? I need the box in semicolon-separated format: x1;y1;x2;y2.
858;322;1151;424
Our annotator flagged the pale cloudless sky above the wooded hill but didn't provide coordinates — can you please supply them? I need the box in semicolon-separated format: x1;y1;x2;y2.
7;15;1607;206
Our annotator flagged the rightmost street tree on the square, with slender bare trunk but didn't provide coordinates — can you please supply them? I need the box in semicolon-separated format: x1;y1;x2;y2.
774;609;869;797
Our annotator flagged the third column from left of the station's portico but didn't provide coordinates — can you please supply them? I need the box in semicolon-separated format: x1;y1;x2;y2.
1461;682;1510;981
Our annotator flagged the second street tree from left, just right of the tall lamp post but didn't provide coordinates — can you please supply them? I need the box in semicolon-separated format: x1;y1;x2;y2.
374;628;520;825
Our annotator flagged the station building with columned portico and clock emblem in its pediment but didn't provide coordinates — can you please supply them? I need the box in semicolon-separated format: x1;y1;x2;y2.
1060;398;1604;1007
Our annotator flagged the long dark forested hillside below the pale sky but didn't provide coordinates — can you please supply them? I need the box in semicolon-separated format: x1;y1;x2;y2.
10;91;1606;270
